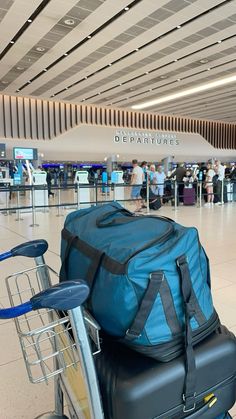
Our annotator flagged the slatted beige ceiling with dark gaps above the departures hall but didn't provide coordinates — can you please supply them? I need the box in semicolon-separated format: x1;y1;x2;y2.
0;0;236;123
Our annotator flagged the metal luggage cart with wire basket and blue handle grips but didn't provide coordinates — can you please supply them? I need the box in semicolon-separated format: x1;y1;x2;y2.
0;240;104;419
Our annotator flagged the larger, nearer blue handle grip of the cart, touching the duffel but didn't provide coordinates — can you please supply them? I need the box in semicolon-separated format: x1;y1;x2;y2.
0;280;89;319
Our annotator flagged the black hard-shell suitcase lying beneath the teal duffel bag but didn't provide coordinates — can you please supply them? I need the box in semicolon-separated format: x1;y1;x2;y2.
96;327;236;419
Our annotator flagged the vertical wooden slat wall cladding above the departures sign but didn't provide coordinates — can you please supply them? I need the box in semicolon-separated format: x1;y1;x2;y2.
0;95;236;149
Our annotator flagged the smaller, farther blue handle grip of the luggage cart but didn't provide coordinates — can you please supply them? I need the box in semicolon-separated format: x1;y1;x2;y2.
0;239;48;262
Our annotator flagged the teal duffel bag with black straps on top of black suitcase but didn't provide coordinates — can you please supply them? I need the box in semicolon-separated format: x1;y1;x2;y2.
60;203;219;361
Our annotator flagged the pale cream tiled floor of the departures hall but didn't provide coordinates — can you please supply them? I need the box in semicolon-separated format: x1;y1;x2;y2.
0;203;236;419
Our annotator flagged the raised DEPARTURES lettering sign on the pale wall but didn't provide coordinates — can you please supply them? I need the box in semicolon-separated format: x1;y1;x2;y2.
114;130;180;147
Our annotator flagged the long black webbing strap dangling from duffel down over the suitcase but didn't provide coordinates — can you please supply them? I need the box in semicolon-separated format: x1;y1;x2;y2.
176;255;196;412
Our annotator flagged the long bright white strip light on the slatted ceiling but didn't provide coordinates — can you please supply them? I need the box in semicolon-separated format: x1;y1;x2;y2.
132;74;236;109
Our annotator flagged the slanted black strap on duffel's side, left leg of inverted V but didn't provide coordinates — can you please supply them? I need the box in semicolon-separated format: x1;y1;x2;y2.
125;271;164;340
